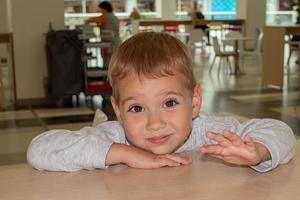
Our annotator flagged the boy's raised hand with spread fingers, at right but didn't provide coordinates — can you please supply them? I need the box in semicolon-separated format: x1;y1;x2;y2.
200;130;271;165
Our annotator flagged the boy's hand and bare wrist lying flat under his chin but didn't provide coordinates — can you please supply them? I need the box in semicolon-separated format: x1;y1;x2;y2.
106;144;192;169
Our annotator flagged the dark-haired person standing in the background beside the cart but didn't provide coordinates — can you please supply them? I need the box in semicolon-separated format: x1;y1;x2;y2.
85;1;121;66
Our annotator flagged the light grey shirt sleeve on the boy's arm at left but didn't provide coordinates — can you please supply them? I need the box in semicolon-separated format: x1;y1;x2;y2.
27;122;125;171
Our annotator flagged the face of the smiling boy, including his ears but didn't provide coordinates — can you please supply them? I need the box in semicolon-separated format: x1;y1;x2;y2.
112;75;201;154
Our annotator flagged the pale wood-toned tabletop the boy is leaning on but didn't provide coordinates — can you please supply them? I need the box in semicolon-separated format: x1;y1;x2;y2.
0;141;300;200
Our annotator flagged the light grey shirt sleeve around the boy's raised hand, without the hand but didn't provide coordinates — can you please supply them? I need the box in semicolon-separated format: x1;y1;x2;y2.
202;117;296;172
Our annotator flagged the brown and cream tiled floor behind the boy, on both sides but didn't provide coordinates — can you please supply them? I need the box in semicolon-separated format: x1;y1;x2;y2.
0;45;300;165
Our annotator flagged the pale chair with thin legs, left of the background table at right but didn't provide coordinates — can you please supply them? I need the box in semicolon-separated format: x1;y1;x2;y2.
209;37;236;73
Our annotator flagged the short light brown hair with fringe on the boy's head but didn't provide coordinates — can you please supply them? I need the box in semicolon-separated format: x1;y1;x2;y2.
108;32;197;102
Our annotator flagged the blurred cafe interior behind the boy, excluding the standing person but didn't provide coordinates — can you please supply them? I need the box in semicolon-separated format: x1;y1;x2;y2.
0;0;300;168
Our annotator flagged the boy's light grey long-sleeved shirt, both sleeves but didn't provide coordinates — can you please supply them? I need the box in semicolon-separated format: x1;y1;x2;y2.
27;114;296;172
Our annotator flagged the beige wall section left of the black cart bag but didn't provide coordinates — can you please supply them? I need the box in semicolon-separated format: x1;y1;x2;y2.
11;0;64;100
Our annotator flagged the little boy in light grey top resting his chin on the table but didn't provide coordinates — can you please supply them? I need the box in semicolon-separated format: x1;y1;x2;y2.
27;32;295;172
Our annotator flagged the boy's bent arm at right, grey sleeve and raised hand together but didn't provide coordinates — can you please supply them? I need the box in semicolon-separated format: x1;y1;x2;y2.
201;118;295;172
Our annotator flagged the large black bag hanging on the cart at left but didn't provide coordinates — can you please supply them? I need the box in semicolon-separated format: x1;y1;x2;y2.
46;30;84;98
